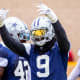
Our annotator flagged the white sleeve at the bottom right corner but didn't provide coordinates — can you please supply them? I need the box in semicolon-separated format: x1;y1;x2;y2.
68;59;80;80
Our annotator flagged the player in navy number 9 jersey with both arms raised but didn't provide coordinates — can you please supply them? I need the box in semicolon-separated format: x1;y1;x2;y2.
0;4;70;80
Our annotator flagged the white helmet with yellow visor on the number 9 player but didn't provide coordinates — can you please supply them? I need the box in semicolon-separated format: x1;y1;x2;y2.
31;16;55;46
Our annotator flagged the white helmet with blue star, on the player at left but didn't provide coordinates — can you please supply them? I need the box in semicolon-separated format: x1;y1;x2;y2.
4;17;30;41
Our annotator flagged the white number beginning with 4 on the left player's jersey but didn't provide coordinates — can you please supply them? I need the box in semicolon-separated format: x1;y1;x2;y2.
14;60;29;80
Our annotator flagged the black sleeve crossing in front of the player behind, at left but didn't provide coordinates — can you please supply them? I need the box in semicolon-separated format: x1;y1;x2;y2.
0;25;28;57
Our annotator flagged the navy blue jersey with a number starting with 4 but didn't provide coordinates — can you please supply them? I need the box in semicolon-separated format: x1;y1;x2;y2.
0;44;30;80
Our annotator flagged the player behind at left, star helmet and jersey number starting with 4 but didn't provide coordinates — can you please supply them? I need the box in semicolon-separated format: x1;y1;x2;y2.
0;17;31;80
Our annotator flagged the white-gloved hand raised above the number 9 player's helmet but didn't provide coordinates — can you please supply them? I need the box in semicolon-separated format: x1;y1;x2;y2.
37;3;58;23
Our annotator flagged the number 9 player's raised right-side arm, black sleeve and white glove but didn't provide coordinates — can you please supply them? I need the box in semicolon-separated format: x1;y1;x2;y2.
37;3;70;53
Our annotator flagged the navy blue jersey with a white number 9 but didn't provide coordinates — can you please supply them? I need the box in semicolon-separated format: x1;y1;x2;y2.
25;42;68;80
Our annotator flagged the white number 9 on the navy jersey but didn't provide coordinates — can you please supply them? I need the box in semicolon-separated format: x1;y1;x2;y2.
37;55;49;77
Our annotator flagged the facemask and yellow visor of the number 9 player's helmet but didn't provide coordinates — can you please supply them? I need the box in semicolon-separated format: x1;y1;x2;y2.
31;29;47;46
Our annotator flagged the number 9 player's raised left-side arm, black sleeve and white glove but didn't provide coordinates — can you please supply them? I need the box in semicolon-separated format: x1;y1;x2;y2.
0;9;27;57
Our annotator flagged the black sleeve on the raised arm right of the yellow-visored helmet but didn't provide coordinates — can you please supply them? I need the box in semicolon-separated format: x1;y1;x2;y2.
52;20;70;53
